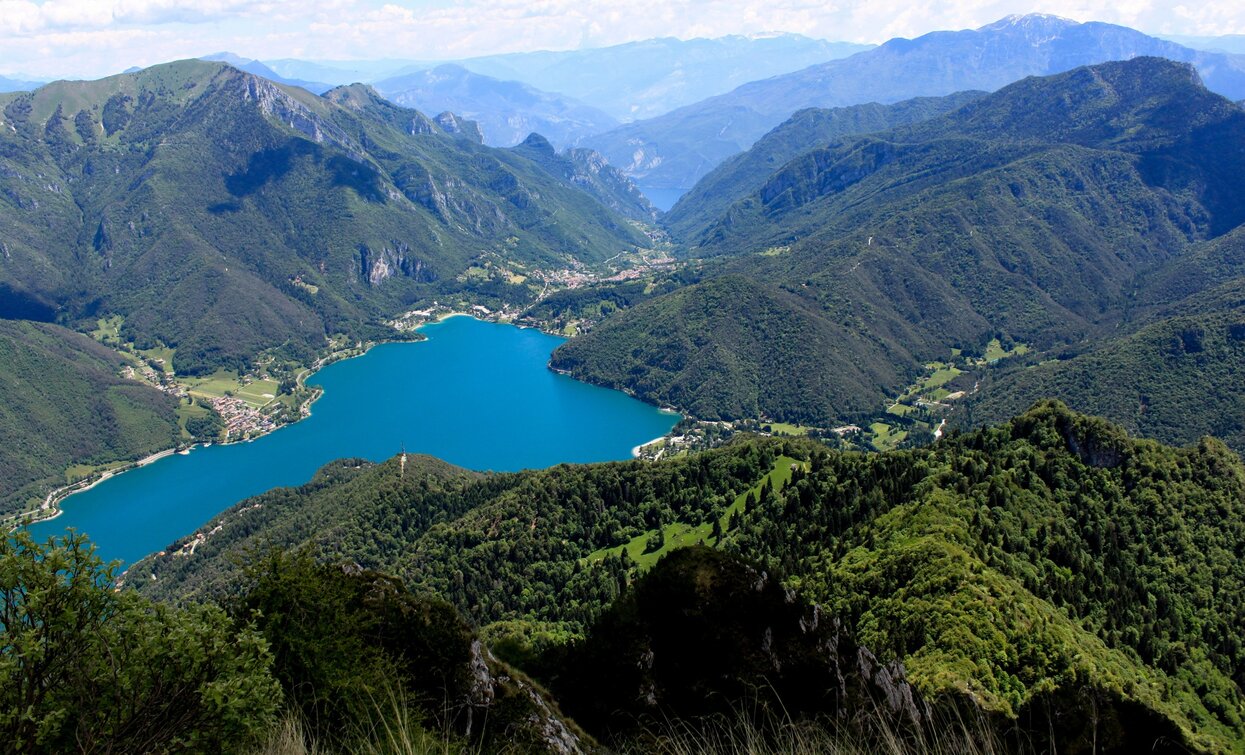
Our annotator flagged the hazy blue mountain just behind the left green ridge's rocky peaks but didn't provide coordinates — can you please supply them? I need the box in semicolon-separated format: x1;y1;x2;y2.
375;65;616;147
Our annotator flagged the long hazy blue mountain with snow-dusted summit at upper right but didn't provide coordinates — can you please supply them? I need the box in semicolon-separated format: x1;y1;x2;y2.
584;15;1245;198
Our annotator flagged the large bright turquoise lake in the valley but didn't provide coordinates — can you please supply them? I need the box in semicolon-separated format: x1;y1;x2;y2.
31;316;679;563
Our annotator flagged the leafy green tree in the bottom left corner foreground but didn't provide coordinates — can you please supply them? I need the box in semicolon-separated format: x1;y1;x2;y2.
0;531;281;753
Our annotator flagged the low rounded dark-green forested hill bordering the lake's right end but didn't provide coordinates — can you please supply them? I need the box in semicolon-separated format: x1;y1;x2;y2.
550;275;914;422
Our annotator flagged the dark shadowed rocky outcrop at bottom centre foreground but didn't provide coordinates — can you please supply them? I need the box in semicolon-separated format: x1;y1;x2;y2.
540;547;933;736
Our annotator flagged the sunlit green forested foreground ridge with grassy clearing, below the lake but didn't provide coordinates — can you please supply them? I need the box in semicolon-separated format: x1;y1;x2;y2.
127;402;1245;753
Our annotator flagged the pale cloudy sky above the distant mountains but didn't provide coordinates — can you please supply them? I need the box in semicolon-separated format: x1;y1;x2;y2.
0;0;1245;78
